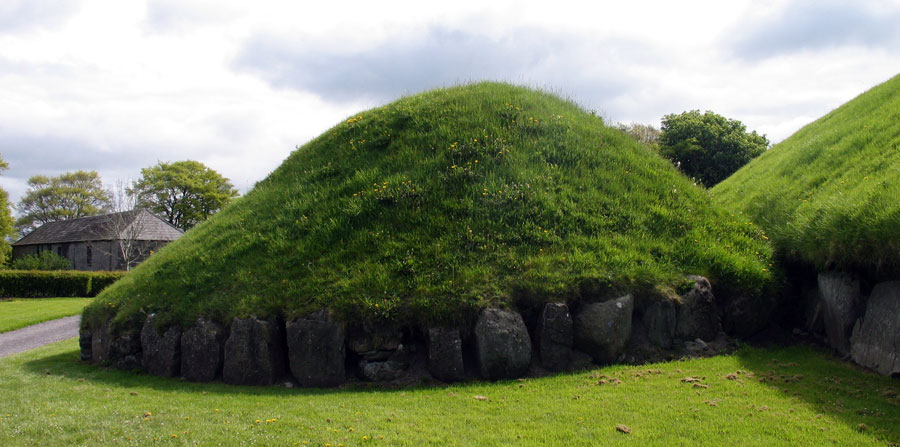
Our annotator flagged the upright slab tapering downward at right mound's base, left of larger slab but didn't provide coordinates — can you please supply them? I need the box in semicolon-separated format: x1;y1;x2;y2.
818;272;862;354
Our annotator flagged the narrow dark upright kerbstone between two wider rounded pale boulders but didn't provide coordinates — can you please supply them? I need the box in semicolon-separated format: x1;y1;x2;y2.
535;303;575;371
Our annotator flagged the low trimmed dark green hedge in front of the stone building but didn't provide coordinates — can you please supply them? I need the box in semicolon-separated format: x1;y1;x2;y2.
0;270;125;298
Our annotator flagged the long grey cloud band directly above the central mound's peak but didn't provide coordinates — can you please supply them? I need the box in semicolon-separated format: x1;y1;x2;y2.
234;27;658;106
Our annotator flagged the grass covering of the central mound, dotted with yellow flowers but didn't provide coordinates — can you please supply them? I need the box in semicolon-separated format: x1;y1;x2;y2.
85;83;771;327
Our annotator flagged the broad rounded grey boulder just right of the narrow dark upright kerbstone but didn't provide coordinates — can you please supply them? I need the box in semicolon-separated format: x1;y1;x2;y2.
575;294;634;363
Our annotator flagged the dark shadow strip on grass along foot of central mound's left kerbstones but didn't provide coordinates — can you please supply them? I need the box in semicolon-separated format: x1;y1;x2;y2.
23;349;486;396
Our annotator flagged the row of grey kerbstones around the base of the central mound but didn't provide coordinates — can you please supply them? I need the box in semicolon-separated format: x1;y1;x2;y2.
81;277;721;387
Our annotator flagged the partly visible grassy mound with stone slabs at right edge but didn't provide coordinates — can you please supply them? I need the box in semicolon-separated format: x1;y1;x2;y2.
712;76;900;374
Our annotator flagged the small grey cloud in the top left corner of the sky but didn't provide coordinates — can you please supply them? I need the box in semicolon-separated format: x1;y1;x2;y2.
0;0;81;33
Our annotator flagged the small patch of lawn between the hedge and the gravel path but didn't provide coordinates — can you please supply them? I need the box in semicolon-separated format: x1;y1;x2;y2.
0;298;93;332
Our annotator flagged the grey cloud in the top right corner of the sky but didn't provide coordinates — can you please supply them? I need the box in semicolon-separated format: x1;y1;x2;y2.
730;0;900;60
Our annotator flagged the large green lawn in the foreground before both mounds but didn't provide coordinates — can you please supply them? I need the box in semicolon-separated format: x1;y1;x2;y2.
0;340;900;447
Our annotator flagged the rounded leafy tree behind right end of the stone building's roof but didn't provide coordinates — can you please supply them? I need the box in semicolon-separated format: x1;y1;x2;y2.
130;160;238;230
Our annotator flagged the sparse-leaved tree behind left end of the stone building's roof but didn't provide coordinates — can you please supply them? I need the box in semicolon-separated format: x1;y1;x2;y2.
16;171;112;234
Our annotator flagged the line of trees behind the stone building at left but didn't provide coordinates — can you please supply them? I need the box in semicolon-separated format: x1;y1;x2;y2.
0;157;238;264
